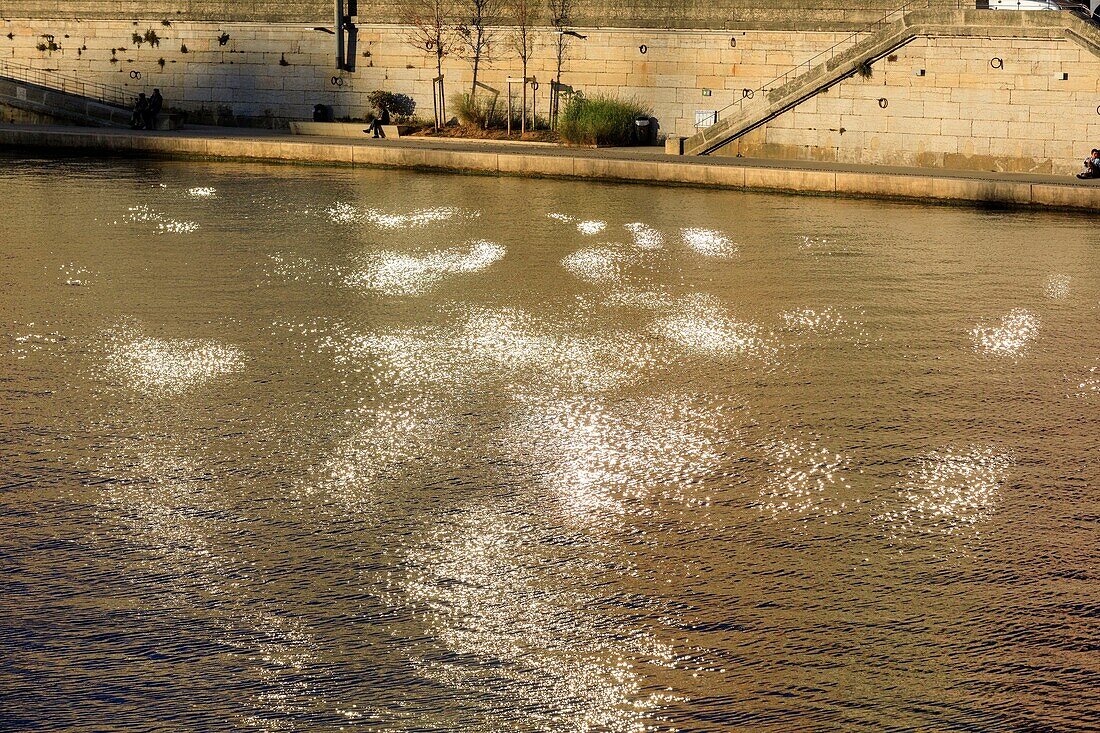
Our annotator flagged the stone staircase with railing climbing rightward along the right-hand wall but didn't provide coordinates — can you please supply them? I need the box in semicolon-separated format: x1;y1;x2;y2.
683;10;1100;155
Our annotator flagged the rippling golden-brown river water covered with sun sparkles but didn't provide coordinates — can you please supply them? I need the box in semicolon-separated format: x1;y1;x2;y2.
0;150;1100;732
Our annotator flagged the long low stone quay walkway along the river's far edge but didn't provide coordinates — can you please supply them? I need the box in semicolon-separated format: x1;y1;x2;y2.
0;125;1100;211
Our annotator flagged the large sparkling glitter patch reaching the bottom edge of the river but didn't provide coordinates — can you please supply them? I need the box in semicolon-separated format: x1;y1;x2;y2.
396;506;673;733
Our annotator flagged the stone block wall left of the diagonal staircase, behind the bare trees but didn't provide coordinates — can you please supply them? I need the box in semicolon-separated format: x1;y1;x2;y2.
0;19;851;135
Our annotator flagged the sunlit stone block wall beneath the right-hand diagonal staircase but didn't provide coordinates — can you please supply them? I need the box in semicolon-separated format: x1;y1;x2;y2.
719;37;1100;174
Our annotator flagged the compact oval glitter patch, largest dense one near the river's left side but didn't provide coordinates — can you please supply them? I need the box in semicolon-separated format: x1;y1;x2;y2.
108;328;244;396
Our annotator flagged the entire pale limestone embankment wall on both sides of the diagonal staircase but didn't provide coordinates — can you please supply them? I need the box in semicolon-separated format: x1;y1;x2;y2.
0;0;1100;174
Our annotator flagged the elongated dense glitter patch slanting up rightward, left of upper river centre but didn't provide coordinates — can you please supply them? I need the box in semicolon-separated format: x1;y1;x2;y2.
344;240;505;295
